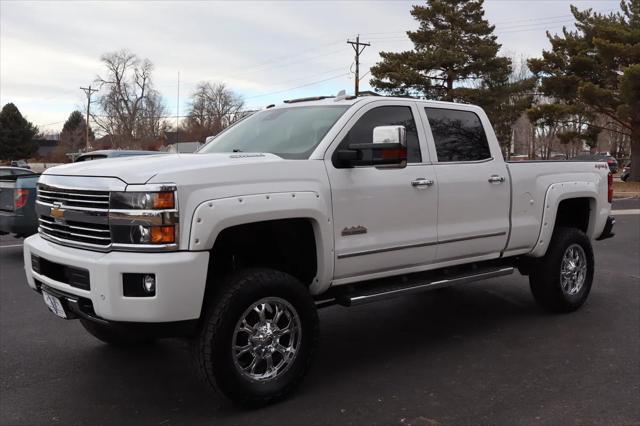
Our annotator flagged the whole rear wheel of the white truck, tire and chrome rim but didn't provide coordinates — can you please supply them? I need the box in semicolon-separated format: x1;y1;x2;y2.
529;228;594;312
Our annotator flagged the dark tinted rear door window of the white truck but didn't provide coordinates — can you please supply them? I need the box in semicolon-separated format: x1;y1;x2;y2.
425;108;491;161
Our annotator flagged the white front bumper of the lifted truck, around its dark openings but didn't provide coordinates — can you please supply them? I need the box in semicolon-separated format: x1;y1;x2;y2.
24;235;209;323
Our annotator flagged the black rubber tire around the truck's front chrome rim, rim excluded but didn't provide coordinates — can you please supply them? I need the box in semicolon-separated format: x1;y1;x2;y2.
192;268;318;406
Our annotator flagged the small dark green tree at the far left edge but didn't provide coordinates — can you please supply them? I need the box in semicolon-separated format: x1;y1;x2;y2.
0;103;38;160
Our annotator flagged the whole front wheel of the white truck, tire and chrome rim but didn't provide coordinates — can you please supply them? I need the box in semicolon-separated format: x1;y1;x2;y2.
194;268;318;405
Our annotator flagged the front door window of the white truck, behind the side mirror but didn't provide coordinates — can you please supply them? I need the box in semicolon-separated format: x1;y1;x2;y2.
339;106;422;163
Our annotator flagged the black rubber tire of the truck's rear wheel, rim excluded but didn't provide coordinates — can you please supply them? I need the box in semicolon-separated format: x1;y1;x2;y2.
529;227;594;312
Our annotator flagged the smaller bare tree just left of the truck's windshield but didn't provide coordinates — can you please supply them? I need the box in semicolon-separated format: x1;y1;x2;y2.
186;81;244;142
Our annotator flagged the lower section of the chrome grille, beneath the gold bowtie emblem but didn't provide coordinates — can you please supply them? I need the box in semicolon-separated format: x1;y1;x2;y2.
39;215;111;246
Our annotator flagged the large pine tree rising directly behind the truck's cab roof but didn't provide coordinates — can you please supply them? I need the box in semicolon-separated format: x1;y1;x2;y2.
370;0;533;153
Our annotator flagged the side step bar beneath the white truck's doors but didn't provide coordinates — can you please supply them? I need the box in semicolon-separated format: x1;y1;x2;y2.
335;267;514;306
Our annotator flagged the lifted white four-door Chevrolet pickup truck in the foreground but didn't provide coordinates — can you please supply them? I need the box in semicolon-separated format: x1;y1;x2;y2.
24;96;614;404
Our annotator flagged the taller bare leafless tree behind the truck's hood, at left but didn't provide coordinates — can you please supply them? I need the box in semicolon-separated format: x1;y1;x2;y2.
92;50;167;148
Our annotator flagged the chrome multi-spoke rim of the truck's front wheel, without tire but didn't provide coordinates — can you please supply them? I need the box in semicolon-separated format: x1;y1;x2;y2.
232;297;302;381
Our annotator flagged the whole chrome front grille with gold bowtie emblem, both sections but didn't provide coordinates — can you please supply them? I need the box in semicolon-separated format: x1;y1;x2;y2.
37;184;112;250
